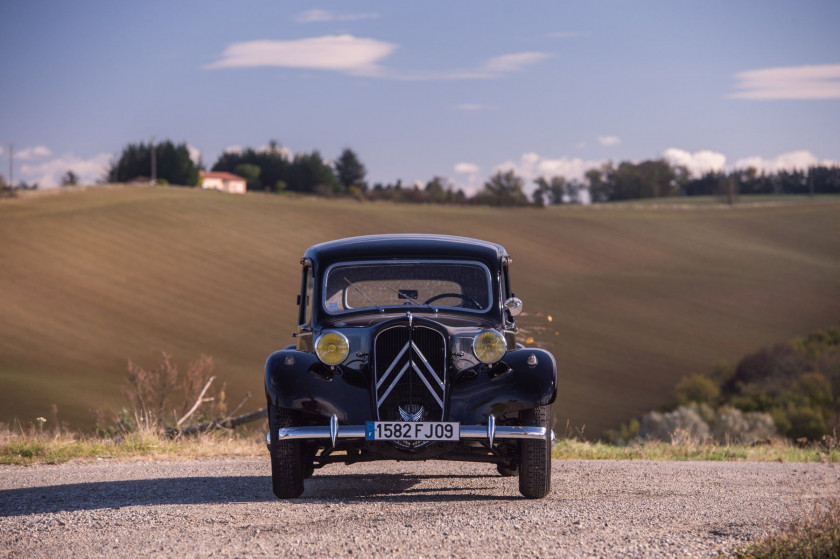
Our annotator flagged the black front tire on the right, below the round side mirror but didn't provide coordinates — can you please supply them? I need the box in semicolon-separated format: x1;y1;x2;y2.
519;406;551;499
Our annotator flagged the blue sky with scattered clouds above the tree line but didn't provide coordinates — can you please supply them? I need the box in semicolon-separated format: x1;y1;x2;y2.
0;0;840;189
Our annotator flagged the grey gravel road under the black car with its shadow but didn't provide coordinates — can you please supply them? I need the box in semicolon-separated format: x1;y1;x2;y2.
0;455;840;558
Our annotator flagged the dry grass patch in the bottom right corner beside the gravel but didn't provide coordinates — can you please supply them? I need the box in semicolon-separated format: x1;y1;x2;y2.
736;497;840;559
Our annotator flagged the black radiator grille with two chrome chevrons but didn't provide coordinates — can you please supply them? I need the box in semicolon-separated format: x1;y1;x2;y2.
373;325;446;421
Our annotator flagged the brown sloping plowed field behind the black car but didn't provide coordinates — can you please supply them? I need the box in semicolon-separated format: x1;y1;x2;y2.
0;187;840;435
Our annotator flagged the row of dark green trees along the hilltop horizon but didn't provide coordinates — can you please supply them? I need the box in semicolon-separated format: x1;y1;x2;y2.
105;140;840;207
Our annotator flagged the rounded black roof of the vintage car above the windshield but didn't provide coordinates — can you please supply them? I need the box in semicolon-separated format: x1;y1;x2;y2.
304;234;507;266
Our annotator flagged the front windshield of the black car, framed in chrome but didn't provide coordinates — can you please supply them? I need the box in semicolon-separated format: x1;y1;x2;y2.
324;260;492;314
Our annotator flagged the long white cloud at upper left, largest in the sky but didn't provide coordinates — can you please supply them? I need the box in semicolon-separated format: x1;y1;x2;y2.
206;35;397;76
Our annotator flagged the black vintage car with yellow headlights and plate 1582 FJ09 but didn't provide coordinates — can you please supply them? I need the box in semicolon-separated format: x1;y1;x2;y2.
265;235;557;498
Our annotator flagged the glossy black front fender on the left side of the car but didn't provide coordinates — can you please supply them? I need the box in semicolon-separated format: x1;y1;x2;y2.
265;349;371;425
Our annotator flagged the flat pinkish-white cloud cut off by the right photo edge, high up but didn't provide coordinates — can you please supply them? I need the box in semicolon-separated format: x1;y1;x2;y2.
729;64;840;100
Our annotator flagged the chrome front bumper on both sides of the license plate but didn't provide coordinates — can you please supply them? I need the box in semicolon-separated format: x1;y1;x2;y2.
265;414;556;446
